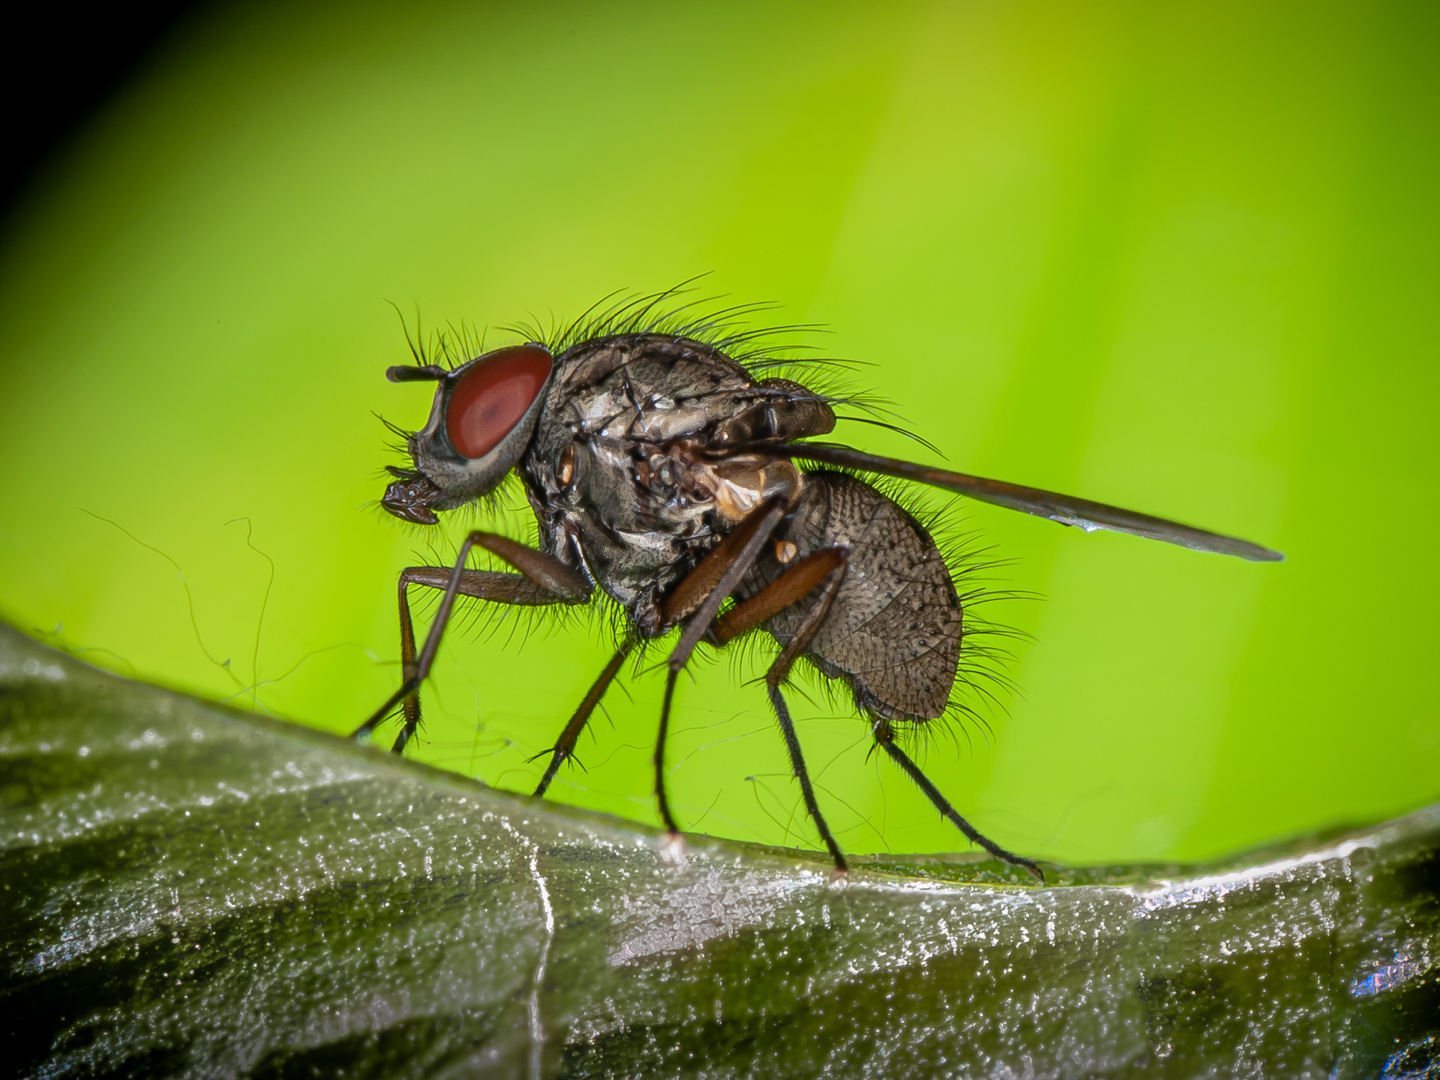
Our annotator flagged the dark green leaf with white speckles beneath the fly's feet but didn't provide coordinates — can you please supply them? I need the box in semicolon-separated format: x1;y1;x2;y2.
0;628;1440;1077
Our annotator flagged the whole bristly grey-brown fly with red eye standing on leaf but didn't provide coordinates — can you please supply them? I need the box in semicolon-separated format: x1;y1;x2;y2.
356;294;1283;880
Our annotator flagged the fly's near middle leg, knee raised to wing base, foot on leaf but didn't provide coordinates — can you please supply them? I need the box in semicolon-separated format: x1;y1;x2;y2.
655;495;789;835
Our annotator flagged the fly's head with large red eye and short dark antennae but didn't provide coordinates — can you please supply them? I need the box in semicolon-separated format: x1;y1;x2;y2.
382;344;554;526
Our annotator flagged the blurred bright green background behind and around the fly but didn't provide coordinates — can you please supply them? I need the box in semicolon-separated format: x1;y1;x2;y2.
0;3;1440;860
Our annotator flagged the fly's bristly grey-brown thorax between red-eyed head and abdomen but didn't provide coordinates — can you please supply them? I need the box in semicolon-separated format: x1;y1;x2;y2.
509;334;834;634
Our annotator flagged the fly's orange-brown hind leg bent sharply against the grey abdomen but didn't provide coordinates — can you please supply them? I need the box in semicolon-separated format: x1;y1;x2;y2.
711;547;848;873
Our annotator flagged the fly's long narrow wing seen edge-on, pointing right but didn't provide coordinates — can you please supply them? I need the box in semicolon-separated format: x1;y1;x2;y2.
772;442;1284;563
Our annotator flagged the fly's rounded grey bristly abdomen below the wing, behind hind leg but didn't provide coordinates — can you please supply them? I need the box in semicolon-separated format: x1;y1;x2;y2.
765;472;962;721
